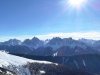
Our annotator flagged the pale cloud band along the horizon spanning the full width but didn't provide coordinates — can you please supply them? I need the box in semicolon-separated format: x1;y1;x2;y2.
0;32;100;41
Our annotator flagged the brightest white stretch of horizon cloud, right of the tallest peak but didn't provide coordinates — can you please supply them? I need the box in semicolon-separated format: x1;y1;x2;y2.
37;32;100;40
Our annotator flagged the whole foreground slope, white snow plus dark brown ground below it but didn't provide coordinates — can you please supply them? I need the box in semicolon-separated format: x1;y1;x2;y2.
0;51;96;75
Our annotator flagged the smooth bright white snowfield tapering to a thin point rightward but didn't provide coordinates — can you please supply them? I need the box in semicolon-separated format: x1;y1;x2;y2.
0;51;52;66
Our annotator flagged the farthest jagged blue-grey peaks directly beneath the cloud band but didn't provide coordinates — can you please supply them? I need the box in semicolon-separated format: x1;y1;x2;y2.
0;37;100;49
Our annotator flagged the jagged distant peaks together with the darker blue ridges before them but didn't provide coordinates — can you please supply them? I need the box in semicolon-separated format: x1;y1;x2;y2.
0;37;100;56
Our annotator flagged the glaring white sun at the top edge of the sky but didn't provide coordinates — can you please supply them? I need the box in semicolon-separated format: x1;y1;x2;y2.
68;0;86;9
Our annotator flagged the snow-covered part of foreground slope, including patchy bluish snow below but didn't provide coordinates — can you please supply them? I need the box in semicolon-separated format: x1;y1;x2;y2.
0;51;56;75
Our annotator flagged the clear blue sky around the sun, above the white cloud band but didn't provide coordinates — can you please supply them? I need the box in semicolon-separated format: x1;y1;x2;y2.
0;0;100;40
